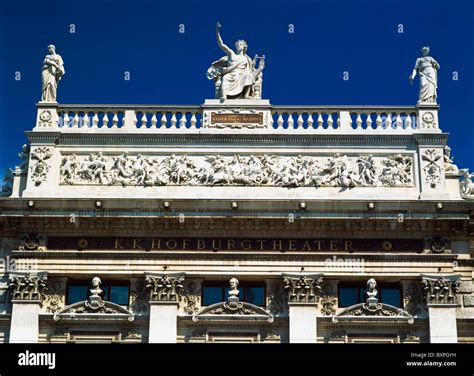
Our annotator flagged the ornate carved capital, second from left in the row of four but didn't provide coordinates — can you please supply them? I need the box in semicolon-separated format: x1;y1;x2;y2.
145;273;184;303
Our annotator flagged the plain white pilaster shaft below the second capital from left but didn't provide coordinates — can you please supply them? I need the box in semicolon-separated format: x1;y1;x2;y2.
148;302;178;343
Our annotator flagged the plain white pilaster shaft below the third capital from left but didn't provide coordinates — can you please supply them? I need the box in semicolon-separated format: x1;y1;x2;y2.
289;304;317;343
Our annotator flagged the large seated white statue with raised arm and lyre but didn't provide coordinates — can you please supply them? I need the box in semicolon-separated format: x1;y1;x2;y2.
207;22;265;102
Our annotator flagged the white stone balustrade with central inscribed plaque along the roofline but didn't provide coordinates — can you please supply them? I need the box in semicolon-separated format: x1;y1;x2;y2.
34;103;441;134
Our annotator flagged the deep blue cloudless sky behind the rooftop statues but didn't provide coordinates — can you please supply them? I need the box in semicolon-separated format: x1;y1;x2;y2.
0;0;474;178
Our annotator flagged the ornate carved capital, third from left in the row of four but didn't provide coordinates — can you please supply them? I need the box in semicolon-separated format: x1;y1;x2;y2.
283;273;323;304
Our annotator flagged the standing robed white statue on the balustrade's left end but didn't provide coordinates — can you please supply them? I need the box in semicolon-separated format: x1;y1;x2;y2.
41;44;66;102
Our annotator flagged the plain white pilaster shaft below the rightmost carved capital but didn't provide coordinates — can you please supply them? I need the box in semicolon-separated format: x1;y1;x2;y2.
428;306;458;343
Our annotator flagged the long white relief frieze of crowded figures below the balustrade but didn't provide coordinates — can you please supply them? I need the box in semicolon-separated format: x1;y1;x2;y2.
60;152;413;188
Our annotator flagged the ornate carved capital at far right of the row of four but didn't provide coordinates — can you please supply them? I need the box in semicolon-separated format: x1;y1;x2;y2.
421;274;461;304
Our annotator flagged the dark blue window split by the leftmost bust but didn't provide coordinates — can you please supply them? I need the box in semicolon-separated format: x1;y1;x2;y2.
66;281;130;305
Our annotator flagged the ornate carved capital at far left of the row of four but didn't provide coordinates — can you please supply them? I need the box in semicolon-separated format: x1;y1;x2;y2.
8;272;48;302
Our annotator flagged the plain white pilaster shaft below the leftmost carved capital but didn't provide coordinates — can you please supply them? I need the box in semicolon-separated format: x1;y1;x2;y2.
10;300;41;343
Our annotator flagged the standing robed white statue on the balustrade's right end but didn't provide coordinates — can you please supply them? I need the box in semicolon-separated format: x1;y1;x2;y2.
409;47;439;104
